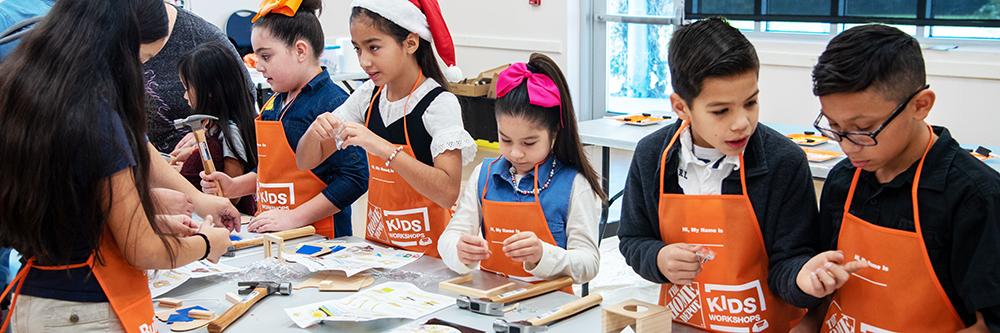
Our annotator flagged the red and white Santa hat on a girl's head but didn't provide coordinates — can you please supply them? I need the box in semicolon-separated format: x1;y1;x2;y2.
351;0;462;82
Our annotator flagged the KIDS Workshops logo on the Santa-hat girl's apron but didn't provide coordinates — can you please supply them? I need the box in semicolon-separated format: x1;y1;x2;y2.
368;206;433;246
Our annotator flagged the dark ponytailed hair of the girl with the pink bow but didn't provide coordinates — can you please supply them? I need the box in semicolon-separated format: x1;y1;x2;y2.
495;53;607;201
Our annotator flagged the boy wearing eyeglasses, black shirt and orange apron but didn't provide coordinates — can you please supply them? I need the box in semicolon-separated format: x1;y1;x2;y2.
813;24;1000;332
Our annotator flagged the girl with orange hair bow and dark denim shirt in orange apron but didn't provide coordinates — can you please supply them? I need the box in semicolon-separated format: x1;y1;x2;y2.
201;0;368;238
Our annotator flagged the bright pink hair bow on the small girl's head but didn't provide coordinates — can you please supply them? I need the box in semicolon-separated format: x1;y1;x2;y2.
497;62;565;127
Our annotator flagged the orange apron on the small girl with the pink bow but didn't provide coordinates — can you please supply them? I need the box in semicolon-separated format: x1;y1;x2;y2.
480;158;573;294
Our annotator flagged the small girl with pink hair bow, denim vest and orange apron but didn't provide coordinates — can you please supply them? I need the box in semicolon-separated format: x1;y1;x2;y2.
438;54;604;293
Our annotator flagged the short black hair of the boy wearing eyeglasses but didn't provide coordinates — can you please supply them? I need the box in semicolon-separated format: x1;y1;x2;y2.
812;24;927;102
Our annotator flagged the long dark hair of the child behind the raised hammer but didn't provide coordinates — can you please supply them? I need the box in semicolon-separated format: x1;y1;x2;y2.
177;41;257;173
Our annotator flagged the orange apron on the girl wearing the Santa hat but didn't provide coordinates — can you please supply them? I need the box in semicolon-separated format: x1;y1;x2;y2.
365;80;451;258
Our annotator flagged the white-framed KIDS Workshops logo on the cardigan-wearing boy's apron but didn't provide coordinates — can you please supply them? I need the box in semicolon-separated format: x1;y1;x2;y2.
704;280;769;332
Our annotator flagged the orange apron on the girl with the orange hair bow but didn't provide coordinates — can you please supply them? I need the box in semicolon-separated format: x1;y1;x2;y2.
254;79;335;238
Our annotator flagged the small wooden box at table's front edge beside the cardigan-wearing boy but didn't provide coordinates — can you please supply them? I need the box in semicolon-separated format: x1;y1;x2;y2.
601;299;673;333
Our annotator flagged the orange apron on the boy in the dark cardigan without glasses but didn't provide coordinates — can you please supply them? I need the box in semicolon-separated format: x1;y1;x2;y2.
659;121;805;332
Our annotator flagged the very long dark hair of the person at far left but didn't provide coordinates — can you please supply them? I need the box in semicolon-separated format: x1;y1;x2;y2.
0;0;176;264
